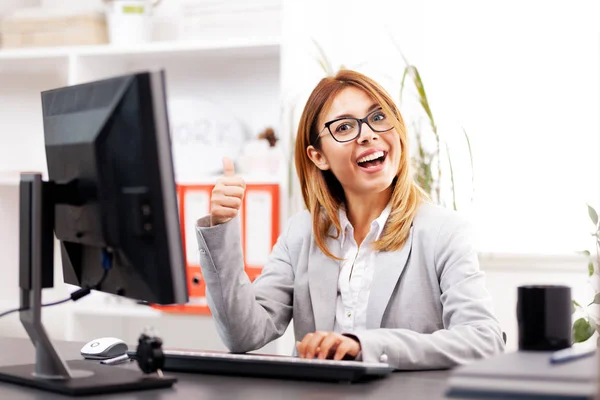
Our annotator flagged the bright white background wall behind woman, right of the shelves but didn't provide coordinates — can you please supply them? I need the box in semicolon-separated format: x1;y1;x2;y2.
284;0;600;253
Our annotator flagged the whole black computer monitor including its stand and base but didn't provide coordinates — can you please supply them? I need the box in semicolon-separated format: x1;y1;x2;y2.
0;71;188;394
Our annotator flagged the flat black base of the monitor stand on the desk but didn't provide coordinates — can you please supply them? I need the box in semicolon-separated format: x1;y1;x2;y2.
0;360;177;396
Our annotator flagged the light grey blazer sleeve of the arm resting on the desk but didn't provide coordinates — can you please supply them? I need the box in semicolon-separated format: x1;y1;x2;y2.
350;214;504;370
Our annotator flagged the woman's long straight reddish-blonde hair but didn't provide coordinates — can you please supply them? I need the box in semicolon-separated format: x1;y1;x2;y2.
295;70;427;259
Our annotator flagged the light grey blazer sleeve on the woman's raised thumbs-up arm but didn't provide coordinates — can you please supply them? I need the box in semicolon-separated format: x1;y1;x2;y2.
196;217;294;353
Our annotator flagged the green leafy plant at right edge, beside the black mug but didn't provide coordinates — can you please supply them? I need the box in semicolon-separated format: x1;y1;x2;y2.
573;205;600;346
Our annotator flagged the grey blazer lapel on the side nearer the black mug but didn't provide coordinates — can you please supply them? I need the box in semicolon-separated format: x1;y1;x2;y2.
367;227;413;329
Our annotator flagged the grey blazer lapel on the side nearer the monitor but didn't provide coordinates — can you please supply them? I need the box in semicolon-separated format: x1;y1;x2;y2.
308;234;341;331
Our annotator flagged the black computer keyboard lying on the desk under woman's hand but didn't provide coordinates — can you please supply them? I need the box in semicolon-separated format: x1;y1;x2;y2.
127;350;394;382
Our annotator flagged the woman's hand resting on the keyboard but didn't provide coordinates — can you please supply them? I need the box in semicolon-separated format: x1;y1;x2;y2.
296;331;360;360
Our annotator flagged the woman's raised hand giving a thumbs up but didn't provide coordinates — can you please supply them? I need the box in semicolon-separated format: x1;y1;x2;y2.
210;157;246;226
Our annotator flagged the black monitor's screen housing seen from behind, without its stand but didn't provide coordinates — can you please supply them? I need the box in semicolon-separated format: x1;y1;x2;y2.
42;73;187;304
